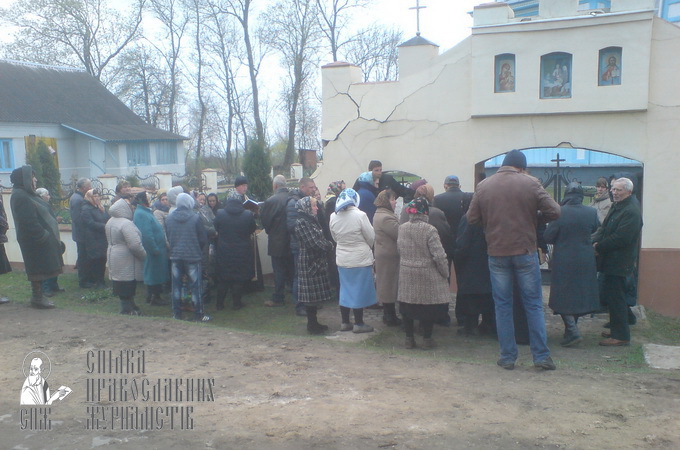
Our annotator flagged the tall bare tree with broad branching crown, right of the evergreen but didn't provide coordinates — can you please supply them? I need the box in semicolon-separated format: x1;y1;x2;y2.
265;0;321;166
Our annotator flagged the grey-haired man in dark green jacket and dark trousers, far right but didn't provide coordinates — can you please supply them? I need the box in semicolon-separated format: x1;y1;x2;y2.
593;178;642;346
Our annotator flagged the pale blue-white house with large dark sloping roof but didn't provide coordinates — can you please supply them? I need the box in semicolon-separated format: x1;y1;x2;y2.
0;61;186;187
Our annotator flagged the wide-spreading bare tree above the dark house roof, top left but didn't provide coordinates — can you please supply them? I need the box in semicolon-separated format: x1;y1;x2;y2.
1;0;144;84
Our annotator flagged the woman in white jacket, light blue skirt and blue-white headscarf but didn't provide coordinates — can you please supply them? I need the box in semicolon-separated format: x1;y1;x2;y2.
330;189;376;333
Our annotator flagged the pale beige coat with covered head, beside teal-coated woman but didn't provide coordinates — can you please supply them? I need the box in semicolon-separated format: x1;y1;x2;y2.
105;199;146;281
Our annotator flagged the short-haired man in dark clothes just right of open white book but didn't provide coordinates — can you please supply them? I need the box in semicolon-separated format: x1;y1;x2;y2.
260;175;293;306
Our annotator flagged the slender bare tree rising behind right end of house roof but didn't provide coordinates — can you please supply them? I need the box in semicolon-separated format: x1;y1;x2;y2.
150;0;189;133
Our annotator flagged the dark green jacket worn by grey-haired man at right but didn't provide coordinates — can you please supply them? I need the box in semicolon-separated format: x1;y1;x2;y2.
593;195;642;277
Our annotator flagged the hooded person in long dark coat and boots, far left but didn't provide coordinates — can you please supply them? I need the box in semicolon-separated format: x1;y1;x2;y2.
10;166;64;309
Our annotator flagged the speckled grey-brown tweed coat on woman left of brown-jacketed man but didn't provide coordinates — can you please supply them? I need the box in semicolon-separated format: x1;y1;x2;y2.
397;217;451;305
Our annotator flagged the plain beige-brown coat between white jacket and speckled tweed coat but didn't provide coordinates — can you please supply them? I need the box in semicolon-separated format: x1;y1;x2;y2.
373;208;399;303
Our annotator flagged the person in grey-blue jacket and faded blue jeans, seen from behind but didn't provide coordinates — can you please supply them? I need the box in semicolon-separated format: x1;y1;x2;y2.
165;193;210;322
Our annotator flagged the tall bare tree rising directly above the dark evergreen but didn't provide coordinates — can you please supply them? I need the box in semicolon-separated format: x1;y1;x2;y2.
222;0;265;142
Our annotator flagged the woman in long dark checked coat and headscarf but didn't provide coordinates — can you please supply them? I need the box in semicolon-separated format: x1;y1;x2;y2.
295;197;333;334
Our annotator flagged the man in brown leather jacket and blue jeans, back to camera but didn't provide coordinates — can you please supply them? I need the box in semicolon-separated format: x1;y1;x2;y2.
467;150;560;370
